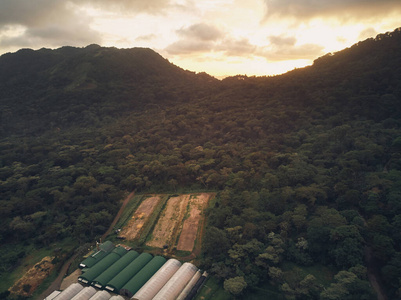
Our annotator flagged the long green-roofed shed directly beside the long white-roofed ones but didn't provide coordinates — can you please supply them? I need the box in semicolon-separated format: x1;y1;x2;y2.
120;256;166;297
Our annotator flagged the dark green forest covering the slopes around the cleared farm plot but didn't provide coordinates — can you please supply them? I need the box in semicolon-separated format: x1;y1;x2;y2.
0;29;401;300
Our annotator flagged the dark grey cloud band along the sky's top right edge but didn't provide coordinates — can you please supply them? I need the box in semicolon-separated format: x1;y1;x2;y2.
264;0;401;19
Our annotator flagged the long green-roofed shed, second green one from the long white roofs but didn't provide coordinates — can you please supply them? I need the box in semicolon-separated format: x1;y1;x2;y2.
106;253;152;294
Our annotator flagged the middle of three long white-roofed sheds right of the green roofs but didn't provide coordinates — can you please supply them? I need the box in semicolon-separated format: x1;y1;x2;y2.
153;263;198;300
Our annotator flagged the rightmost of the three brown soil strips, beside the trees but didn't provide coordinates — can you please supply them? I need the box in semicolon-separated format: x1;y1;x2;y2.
177;193;211;251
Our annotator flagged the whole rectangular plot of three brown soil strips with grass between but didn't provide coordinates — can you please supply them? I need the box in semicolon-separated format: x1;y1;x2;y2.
119;193;214;253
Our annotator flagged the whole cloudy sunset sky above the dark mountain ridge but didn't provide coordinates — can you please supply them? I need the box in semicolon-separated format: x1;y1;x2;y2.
0;0;401;77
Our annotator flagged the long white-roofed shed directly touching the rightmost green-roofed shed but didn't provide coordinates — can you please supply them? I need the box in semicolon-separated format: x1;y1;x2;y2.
132;258;181;300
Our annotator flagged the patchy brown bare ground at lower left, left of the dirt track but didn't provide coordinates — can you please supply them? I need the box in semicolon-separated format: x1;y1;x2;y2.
9;256;54;297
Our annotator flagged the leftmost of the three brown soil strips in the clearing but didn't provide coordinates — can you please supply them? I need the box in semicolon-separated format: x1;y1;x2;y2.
119;196;161;240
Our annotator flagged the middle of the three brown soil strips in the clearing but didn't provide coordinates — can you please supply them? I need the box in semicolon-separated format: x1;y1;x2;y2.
146;195;190;248
